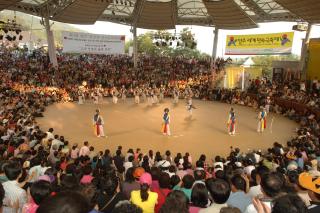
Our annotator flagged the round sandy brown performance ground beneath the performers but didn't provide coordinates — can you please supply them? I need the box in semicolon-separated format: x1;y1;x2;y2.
38;99;297;158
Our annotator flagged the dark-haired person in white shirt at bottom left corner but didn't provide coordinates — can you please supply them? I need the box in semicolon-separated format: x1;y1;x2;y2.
3;161;27;213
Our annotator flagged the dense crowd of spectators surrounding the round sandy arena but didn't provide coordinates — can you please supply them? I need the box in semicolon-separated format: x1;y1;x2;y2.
0;45;320;213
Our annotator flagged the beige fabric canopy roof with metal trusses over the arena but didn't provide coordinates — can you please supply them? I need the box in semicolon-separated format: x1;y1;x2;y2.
0;0;320;29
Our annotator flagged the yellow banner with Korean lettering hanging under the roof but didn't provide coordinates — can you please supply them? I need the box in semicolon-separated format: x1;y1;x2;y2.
225;32;294;55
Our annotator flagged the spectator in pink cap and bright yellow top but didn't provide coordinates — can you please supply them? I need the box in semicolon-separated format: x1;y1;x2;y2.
131;172;158;213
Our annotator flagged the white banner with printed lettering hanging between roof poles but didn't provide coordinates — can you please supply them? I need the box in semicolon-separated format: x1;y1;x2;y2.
62;31;125;54
